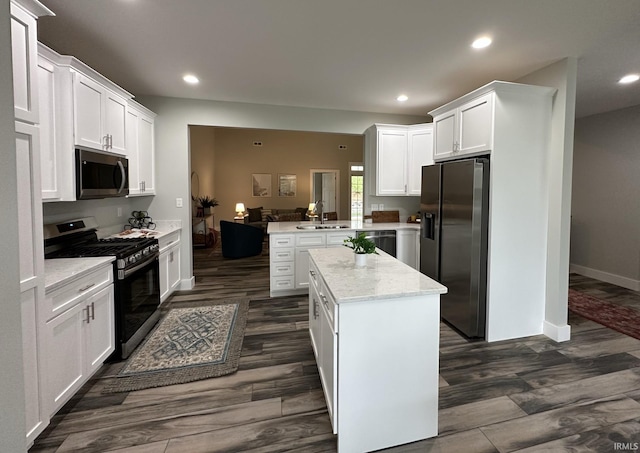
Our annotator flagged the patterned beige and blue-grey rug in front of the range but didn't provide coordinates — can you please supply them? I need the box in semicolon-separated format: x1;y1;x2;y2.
103;300;249;393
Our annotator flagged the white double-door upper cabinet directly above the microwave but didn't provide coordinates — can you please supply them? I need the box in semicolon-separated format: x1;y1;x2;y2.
73;73;127;154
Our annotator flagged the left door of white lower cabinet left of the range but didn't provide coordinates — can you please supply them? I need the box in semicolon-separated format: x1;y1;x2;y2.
43;303;86;414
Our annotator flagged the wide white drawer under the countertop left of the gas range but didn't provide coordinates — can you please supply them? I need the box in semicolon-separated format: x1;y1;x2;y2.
45;263;113;319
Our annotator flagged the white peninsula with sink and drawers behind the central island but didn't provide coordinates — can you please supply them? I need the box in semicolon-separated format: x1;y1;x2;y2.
267;220;420;297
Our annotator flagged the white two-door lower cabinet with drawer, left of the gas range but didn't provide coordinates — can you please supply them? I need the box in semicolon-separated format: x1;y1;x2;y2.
42;263;115;414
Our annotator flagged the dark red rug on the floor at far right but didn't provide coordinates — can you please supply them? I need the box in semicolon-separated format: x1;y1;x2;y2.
569;289;640;340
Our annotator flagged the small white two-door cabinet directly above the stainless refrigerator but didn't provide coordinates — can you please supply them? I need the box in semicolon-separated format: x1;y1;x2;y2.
431;93;495;161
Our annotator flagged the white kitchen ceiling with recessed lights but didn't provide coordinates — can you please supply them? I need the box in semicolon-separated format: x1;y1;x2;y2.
39;0;640;117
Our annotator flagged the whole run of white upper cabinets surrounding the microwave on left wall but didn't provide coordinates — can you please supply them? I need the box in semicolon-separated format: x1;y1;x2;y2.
37;44;155;201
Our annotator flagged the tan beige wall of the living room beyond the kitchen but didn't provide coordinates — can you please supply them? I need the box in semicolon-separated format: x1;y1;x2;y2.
190;126;364;223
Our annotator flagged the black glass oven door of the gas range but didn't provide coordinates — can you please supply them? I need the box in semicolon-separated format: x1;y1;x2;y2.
115;253;160;359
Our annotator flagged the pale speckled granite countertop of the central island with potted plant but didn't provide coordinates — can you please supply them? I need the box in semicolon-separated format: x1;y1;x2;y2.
309;247;447;304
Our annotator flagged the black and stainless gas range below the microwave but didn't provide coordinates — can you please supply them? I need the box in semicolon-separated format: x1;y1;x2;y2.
44;217;160;359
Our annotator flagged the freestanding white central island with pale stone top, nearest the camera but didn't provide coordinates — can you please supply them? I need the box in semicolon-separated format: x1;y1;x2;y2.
309;247;447;452
